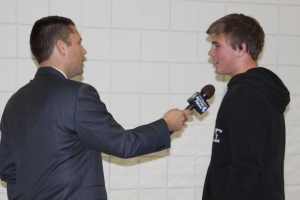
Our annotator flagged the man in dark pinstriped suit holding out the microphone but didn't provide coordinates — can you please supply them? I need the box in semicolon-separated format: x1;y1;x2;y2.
0;16;193;200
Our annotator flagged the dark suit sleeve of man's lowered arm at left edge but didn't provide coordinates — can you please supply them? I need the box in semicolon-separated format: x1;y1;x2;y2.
0;115;16;199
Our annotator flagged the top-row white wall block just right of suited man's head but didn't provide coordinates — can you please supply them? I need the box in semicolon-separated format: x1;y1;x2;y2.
82;0;112;27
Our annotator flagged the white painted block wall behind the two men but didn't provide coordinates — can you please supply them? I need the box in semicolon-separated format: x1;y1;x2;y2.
0;0;300;200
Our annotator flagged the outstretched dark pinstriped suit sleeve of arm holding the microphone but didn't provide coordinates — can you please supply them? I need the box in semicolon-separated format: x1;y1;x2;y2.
75;84;170;158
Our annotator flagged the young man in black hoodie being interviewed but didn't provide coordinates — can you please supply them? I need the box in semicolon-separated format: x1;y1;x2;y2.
203;14;290;200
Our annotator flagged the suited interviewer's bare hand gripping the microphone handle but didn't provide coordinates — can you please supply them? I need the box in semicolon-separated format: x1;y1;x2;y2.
163;108;194;132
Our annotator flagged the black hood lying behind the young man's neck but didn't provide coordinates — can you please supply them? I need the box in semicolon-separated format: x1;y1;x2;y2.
228;67;290;113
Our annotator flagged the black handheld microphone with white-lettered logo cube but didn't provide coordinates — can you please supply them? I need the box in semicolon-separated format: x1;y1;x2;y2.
185;85;215;114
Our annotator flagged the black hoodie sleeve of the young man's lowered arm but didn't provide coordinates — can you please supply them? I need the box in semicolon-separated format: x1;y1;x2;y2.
225;95;266;200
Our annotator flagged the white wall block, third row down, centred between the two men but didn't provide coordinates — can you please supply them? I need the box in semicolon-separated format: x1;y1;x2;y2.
140;63;169;93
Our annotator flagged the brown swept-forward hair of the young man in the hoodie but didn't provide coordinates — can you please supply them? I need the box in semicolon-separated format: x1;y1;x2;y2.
206;14;265;60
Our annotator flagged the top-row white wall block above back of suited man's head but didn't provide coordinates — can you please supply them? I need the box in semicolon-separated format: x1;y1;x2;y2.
18;0;49;24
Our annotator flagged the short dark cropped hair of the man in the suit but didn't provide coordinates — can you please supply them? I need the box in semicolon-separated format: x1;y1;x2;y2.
30;16;75;63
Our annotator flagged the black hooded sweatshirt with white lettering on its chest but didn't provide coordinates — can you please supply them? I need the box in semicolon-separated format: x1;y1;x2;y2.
203;67;290;200
